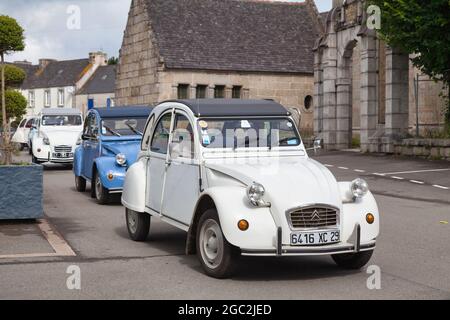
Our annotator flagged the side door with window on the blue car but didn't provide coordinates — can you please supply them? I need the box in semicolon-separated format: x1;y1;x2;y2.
83;112;99;179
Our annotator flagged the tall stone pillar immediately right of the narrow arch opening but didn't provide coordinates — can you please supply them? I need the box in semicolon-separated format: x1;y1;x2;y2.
360;35;378;152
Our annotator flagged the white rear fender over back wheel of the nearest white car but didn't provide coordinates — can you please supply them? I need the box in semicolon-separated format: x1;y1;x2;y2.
122;160;147;212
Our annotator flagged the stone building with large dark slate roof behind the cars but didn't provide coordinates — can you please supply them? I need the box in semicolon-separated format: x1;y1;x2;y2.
116;0;323;131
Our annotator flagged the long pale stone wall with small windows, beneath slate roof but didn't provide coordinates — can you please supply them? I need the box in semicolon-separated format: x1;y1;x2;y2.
155;70;314;133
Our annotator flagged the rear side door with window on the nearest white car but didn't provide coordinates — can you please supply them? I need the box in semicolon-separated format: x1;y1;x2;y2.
146;110;173;214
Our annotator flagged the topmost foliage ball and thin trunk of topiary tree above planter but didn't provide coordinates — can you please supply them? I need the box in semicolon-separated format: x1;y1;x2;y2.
0;15;25;165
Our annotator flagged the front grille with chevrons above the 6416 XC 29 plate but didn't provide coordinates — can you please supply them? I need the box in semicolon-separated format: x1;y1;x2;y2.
287;206;339;229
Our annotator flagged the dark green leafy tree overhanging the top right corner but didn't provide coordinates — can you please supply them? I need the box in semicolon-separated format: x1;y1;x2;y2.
369;0;450;125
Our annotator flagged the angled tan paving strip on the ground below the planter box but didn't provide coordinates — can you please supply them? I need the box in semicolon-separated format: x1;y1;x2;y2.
0;219;76;259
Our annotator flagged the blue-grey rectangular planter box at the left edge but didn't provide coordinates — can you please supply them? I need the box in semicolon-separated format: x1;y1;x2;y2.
0;165;44;220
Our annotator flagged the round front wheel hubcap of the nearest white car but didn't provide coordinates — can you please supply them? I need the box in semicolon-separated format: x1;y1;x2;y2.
199;219;224;269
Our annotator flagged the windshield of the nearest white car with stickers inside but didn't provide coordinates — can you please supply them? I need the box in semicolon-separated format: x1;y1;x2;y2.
198;118;301;149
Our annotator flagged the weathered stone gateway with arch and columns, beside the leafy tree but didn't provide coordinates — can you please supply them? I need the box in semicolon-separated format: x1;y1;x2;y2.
314;0;445;152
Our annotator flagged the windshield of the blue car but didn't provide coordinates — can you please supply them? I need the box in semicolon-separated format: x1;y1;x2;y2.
102;117;147;137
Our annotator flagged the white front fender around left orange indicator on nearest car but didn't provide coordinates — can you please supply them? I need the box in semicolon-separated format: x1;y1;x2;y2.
200;186;277;249
